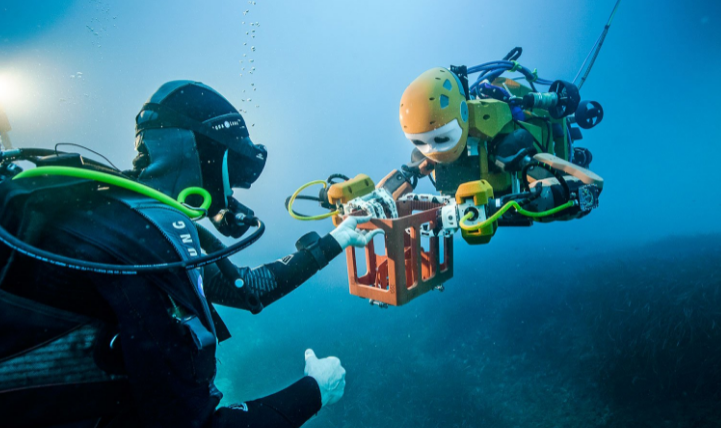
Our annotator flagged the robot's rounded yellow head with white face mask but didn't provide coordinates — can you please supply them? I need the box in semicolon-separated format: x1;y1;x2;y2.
399;67;468;163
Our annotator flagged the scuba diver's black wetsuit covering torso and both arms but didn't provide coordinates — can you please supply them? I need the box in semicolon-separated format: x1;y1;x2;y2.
0;185;341;428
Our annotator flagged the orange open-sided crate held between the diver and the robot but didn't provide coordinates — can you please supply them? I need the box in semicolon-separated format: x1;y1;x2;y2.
346;200;453;306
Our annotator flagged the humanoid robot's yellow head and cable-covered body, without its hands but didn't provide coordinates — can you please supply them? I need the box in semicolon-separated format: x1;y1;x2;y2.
368;52;603;244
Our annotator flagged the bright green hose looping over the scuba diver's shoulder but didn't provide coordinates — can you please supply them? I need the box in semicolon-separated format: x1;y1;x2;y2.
13;166;212;220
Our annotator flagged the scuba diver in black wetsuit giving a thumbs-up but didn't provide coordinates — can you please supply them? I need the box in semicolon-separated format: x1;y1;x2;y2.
0;81;376;427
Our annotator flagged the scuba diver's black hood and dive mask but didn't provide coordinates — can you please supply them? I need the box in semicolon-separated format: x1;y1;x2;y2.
135;80;267;196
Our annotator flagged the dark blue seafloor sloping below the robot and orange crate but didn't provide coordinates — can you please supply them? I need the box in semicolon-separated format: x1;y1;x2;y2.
219;235;721;428
